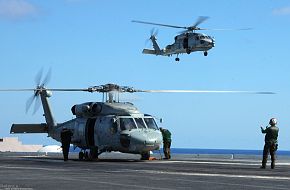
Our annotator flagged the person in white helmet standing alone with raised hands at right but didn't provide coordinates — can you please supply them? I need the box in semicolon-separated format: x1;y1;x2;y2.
261;118;279;169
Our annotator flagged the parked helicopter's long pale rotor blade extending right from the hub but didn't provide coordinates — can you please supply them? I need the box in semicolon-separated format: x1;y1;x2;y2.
138;90;275;94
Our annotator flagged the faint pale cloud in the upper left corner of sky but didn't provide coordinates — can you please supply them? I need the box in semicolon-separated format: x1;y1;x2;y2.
0;0;37;20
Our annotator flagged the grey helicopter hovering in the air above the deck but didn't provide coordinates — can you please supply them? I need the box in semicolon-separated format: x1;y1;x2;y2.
132;16;250;61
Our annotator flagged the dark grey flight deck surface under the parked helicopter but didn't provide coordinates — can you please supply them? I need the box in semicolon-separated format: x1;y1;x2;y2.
0;153;290;190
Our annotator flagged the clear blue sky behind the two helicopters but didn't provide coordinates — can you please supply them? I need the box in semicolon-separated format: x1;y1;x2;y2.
0;0;290;150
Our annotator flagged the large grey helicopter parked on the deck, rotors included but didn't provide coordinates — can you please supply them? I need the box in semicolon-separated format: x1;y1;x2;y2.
0;72;273;160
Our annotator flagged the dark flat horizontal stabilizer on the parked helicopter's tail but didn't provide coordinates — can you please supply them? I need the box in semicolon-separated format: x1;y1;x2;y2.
10;123;47;133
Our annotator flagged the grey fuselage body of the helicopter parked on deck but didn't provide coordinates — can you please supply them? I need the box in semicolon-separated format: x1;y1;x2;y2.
49;102;162;157
